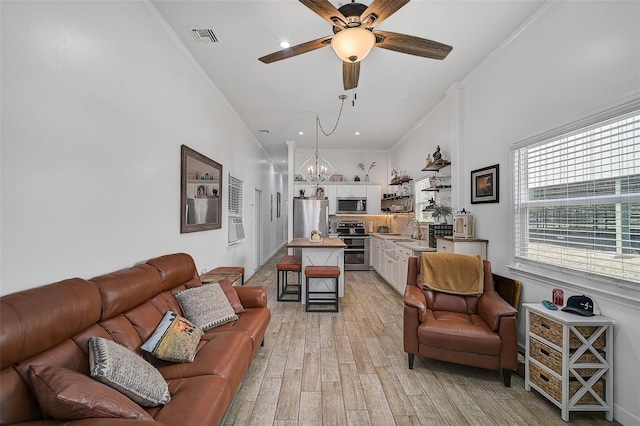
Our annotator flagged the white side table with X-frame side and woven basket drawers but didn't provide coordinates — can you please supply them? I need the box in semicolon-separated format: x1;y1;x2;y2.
522;303;615;421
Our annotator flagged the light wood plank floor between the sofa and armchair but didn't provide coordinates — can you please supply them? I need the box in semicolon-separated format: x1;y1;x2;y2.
224;250;616;426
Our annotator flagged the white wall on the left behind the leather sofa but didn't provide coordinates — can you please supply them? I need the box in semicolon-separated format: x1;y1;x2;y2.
0;1;287;294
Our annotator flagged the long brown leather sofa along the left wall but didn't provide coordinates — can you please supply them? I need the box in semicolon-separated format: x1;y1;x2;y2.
0;253;271;426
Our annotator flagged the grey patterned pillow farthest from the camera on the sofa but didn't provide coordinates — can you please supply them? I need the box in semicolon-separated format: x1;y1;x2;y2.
173;283;238;330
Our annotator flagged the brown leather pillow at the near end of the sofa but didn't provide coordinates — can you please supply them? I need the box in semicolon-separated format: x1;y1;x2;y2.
29;365;153;420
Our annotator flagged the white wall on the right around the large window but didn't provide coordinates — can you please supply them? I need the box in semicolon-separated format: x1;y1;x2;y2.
390;1;640;425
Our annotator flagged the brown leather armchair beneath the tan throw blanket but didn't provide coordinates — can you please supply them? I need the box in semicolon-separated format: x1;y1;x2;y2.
403;257;518;387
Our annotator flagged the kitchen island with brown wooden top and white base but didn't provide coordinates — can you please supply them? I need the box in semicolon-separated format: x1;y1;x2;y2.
287;238;347;304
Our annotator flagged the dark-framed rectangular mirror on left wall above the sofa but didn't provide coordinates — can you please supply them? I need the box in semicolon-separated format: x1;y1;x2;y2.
180;145;222;234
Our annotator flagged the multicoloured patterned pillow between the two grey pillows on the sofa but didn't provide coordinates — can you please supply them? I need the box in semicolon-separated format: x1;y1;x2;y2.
142;311;202;362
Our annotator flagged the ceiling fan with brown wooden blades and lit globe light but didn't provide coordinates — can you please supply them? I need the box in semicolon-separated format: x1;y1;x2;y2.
259;0;453;90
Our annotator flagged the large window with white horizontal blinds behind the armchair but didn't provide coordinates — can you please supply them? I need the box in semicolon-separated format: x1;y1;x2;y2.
514;111;640;283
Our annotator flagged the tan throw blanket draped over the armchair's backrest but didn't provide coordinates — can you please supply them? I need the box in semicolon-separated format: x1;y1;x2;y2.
420;252;484;295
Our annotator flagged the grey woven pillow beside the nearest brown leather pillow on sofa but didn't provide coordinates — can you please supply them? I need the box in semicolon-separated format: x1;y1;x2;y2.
89;337;171;407
